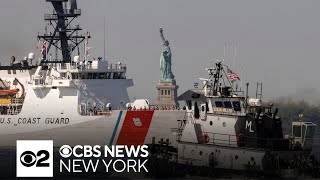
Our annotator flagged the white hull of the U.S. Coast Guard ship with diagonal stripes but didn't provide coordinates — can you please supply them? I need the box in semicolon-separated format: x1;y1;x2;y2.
0;110;185;147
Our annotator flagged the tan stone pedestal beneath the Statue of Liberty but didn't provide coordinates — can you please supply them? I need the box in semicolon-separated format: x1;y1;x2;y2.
156;81;179;109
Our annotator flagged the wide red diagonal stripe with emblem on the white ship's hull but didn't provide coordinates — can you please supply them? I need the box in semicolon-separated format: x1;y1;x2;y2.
117;110;154;146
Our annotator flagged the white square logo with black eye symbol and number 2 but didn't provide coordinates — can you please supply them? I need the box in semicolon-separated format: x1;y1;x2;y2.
16;140;53;177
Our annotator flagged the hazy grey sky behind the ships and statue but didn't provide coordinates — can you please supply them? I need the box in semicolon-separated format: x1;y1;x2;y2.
0;0;320;101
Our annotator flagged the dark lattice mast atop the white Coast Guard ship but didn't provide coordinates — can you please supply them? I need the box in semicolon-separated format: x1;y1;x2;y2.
38;0;86;63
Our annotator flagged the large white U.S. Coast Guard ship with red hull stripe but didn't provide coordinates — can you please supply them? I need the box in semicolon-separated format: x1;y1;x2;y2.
0;0;185;147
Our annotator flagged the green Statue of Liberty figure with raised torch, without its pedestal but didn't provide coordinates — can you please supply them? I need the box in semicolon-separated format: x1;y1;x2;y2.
160;28;175;82
